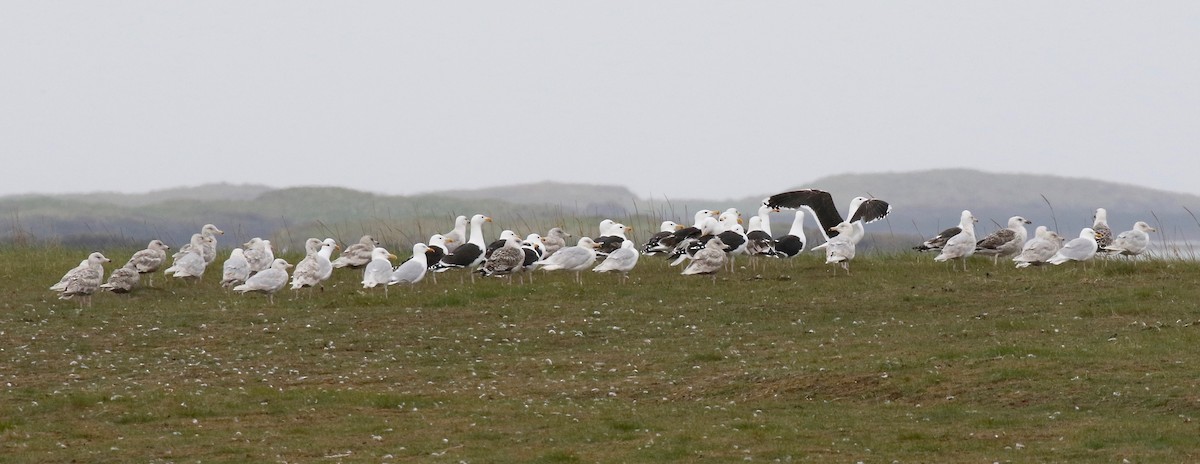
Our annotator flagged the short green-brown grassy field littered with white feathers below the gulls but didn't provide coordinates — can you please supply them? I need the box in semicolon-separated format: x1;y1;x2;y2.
0;247;1200;463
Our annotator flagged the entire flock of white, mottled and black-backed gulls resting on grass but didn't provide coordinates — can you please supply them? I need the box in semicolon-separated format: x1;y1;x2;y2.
50;189;1156;306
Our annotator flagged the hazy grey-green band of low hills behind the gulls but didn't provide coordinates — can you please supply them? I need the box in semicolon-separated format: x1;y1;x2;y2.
0;169;1200;249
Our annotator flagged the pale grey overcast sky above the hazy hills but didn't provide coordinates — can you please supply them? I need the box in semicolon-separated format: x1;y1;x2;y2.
0;0;1200;199
